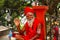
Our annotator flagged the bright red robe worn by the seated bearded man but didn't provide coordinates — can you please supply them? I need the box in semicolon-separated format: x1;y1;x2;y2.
23;19;42;40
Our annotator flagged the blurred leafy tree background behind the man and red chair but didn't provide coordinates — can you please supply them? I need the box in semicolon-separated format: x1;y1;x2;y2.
0;0;60;40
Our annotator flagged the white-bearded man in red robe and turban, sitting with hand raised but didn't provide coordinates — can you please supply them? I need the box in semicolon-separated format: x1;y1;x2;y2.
14;7;42;40
